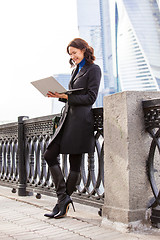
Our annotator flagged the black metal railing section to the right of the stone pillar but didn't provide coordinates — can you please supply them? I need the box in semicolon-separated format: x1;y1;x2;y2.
143;99;160;228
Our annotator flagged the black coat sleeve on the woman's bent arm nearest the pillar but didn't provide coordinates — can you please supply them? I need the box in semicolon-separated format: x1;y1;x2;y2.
68;65;101;106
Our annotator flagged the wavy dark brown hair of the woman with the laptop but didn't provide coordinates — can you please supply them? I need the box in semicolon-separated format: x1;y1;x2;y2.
67;38;96;67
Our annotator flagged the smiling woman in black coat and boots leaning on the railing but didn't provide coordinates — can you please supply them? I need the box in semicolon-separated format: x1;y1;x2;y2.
44;38;101;218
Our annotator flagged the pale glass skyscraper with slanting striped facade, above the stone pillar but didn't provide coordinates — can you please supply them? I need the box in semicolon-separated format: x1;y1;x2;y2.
112;0;160;91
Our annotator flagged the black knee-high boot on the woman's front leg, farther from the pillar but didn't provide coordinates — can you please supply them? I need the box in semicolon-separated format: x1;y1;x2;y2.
44;165;74;218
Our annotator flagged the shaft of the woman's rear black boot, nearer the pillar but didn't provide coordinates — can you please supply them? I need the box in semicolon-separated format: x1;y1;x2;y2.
66;171;80;196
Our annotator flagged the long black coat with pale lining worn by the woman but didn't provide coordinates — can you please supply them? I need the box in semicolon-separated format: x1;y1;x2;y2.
48;64;101;154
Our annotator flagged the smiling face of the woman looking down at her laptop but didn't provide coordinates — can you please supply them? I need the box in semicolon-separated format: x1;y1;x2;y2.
68;47;84;65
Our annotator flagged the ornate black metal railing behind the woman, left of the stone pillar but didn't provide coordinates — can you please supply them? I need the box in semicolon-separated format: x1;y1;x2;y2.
0;108;104;207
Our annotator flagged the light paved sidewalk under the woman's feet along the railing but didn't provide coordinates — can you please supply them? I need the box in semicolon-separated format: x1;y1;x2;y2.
0;186;160;240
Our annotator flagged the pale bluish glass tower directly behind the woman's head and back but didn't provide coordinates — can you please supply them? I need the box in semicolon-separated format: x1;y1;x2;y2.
77;0;105;106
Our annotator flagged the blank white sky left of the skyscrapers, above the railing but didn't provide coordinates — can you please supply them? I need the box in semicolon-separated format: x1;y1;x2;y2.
0;0;79;123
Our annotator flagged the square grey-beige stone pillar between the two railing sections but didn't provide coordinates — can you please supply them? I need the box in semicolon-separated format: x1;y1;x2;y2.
102;91;160;224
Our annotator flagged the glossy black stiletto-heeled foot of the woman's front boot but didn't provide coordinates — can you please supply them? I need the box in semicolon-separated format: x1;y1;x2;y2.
54;195;75;218
